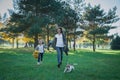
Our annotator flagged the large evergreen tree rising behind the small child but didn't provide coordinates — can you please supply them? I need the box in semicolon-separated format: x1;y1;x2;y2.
4;0;63;47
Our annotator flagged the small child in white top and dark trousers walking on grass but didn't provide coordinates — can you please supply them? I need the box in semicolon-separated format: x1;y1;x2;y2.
35;40;44;65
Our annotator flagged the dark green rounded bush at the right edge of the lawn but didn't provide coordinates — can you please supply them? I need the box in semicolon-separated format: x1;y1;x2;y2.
110;36;120;50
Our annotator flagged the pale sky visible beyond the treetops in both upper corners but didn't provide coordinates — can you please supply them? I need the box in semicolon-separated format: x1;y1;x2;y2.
0;0;120;35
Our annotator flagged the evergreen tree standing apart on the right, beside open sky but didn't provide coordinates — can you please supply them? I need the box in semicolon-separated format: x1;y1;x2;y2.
84;4;119;51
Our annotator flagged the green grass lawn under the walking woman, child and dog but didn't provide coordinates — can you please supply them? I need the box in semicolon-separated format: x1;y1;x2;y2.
0;48;120;80
